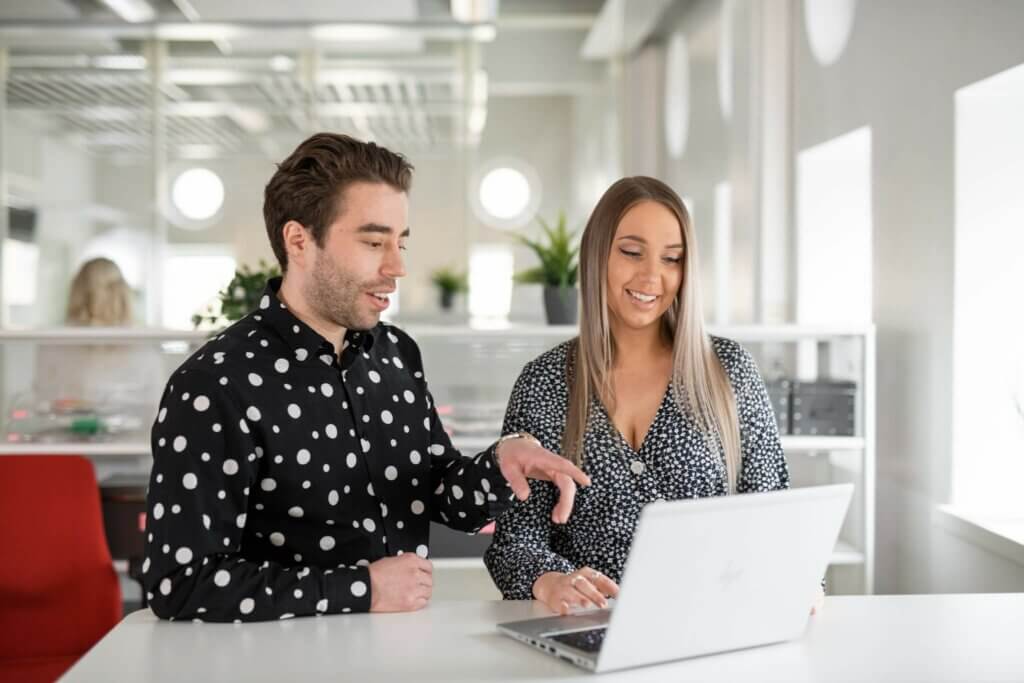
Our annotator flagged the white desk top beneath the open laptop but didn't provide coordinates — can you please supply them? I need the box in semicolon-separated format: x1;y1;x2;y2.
63;594;1024;683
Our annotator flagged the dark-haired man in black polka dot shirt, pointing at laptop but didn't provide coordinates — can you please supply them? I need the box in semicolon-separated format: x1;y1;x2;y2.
142;133;590;622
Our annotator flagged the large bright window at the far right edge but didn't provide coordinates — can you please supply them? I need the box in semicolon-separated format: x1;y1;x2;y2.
952;65;1024;516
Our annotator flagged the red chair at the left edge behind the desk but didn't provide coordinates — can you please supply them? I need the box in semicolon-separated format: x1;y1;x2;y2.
0;456;121;681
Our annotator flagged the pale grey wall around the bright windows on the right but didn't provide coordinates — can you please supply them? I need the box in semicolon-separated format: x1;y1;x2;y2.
794;0;1024;593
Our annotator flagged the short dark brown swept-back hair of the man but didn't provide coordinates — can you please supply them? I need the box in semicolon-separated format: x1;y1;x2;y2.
263;133;413;271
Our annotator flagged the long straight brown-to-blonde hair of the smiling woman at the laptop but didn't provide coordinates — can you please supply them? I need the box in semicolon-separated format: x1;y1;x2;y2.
562;176;740;493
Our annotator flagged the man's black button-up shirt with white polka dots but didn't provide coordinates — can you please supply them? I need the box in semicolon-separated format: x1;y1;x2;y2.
142;279;512;622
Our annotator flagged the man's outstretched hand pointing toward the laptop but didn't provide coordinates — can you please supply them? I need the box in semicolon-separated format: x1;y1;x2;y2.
497;438;590;524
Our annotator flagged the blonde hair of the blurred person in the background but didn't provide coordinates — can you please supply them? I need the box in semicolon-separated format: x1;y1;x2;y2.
66;258;132;327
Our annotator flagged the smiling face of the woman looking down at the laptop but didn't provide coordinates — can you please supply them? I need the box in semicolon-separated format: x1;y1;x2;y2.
608;201;683;330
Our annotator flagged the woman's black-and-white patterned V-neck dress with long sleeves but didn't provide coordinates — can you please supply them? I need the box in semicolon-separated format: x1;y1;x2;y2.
484;337;790;600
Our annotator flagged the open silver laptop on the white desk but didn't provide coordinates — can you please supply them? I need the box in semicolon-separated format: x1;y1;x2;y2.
498;483;853;672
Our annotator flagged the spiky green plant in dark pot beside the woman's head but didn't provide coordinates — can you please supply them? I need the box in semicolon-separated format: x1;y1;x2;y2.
515;211;580;325
